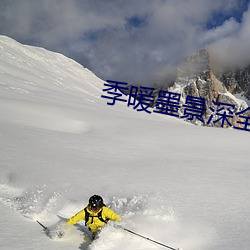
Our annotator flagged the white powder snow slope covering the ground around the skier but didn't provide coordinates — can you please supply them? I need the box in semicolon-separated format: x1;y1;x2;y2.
0;36;250;250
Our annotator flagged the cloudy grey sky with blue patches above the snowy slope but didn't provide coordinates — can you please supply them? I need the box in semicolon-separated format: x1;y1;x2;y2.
0;0;250;85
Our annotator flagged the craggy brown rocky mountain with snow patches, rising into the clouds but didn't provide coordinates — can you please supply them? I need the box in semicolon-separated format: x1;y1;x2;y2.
148;49;250;128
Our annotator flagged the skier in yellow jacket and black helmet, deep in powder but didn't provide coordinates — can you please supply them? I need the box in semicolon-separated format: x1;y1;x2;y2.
67;194;122;239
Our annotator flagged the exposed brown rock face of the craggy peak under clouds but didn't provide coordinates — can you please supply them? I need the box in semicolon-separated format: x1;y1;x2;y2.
156;49;250;127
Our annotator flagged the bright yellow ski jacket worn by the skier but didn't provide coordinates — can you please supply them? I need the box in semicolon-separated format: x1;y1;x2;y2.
67;206;122;233
